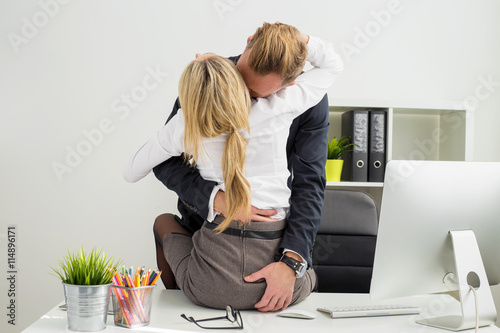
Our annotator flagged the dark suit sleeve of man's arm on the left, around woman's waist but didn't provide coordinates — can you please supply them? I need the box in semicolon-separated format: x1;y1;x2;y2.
153;99;217;219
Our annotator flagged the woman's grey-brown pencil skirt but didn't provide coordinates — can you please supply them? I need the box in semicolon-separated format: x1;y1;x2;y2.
163;217;316;310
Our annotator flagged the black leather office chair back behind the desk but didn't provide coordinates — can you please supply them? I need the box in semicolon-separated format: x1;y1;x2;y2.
312;189;378;293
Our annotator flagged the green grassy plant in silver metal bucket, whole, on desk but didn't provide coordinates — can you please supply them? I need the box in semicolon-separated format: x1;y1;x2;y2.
51;247;121;332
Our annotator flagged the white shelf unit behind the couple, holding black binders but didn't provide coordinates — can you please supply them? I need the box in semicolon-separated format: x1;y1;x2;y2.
326;99;474;207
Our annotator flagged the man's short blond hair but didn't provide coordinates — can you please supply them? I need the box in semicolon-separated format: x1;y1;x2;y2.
246;23;307;86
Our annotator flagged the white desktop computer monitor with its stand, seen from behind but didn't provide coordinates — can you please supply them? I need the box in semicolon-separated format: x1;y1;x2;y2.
370;160;500;330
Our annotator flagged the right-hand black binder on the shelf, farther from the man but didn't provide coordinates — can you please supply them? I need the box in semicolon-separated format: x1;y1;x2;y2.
368;111;387;182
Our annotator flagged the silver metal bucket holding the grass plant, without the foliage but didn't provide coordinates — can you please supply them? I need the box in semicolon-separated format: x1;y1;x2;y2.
63;283;111;332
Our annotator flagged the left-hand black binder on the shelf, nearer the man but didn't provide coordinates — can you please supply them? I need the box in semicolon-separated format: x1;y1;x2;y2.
342;110;369;182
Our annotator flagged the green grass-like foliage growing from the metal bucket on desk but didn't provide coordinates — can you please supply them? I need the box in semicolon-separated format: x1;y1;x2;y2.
49;247;121;285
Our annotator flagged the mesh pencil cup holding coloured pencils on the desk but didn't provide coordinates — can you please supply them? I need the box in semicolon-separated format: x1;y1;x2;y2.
111;285;156;328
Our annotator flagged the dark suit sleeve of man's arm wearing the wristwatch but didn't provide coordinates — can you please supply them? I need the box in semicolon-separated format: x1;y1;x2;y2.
280;95;330;266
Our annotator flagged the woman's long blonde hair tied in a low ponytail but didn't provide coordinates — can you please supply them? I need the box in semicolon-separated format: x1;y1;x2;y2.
179;55;251;232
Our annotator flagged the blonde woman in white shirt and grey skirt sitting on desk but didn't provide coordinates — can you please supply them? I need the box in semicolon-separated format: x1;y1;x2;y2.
124;26;341;309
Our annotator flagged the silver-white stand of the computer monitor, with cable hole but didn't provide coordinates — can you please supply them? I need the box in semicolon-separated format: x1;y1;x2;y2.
417;230;497;331
